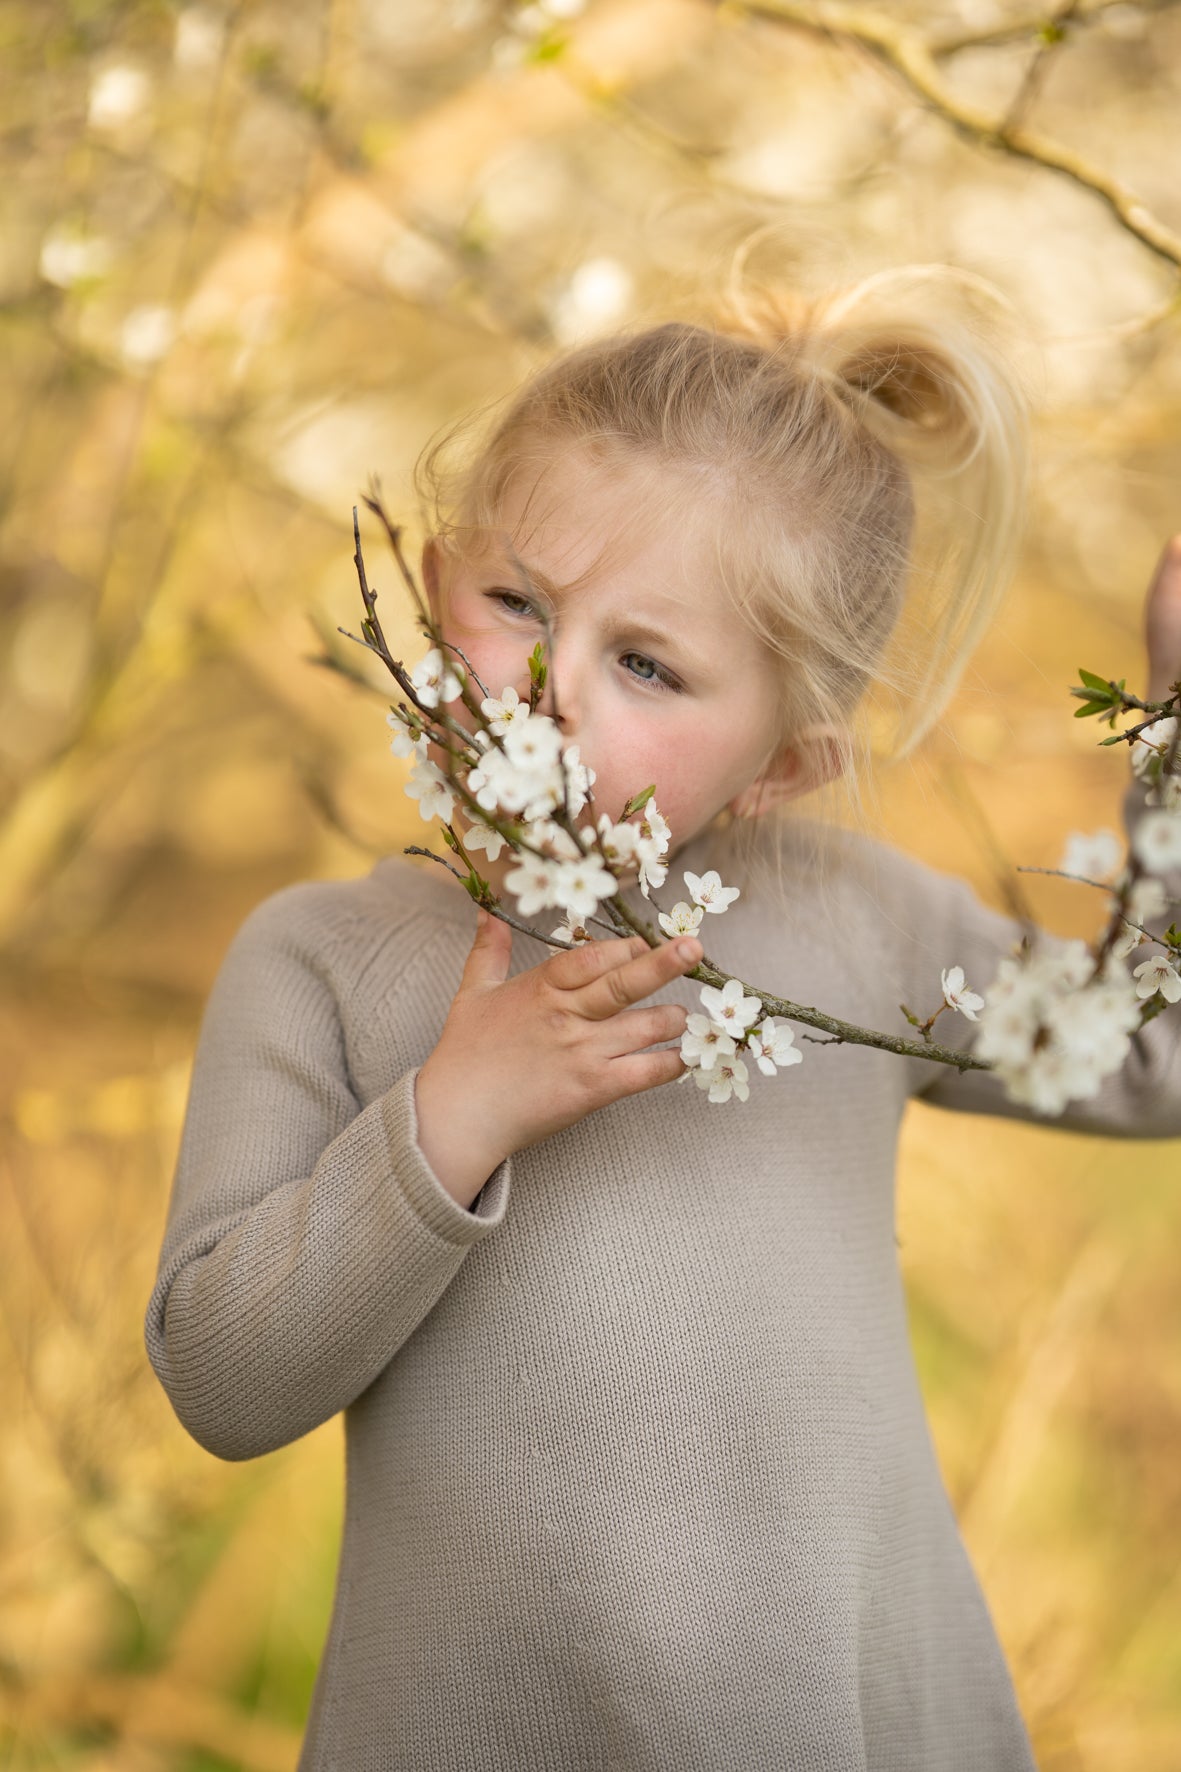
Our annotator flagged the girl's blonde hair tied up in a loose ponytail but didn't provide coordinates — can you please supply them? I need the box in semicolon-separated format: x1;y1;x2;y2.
407;266;1028;942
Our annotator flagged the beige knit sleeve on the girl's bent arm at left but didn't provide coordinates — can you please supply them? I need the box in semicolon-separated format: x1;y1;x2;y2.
145;884;511;1458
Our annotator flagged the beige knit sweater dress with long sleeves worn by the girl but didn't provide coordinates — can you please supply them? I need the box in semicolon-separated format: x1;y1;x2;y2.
147;781;1181;1772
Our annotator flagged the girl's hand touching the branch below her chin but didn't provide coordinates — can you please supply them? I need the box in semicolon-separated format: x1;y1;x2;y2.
415;916;702;1205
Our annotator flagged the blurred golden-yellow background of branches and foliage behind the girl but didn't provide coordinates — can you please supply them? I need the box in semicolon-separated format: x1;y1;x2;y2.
0;0;1181;1772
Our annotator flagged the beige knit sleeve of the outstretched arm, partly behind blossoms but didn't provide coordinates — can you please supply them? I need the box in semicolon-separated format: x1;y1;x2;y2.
897;780;1181;1138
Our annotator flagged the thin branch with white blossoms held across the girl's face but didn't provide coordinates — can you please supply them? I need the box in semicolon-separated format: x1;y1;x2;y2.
342;494;1181;1113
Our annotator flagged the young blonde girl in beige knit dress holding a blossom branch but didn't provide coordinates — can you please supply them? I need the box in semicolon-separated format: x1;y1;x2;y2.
147;265;1181;1772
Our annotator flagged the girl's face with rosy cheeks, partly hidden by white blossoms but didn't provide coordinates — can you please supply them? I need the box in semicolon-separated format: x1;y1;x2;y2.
424;455;819;893
